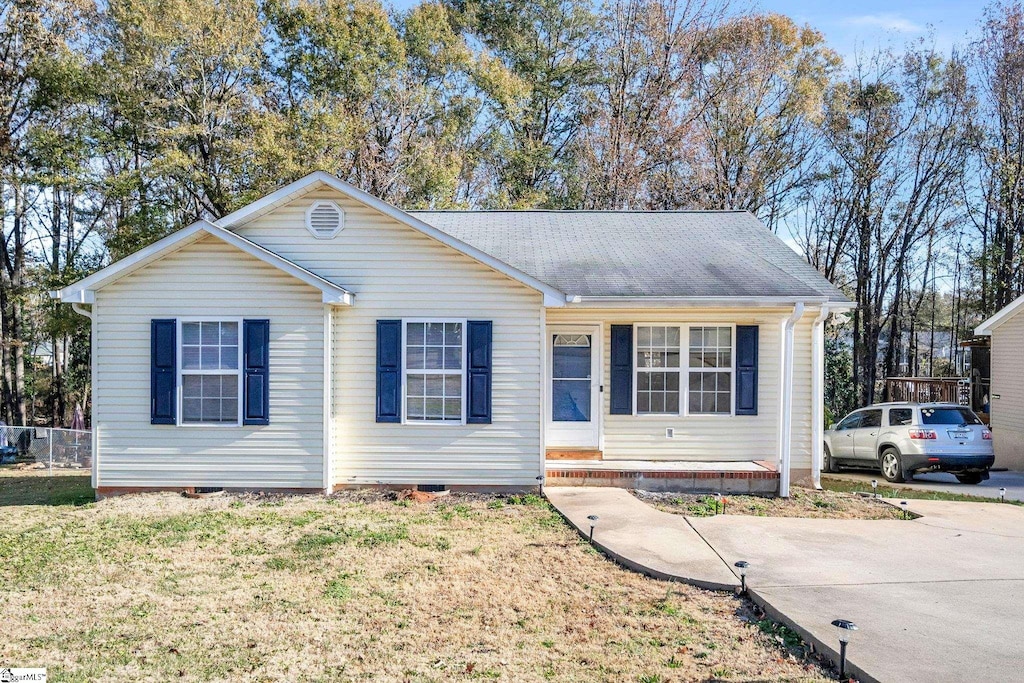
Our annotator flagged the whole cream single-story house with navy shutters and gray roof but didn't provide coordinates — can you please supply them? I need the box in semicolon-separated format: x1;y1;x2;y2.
54;172;851;495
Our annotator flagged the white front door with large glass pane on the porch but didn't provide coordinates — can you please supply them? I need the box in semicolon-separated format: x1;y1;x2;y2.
546;328;601;449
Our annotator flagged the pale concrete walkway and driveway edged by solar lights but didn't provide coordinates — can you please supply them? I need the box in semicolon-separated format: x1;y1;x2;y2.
546;487;1024;683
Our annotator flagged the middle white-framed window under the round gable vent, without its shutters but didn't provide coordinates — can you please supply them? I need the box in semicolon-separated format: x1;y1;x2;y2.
404;322;465;423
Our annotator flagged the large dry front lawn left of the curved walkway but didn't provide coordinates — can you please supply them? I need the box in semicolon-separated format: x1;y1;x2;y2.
0;473;823;682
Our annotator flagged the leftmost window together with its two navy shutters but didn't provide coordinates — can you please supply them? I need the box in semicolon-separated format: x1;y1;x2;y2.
151;317;269;427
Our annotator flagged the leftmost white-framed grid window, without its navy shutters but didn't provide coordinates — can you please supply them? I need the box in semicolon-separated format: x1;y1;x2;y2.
179;321;242;425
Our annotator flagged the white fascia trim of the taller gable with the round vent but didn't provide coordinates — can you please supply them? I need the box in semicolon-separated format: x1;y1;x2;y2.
215;171;565;308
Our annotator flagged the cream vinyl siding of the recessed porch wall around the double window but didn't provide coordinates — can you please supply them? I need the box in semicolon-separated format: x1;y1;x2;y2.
547;308;816;471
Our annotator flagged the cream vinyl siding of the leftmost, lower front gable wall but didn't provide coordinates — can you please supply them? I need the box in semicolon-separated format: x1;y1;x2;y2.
93;237;324;488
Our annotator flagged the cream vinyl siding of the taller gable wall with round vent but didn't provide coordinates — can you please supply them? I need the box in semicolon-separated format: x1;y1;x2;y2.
238;188;543;486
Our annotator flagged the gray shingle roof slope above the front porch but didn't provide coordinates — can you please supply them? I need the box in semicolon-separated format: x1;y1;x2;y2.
409;211;848;302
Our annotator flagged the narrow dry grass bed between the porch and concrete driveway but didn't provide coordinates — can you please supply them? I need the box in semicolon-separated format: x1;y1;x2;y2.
634;486;902;519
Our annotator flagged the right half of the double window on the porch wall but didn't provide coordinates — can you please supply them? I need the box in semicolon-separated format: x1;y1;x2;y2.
687;327;733;415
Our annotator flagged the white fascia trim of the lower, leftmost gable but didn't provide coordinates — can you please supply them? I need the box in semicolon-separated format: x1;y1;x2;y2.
51;220;352;306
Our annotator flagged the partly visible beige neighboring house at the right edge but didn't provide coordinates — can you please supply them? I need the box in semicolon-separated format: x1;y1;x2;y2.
975;296;1024;470
